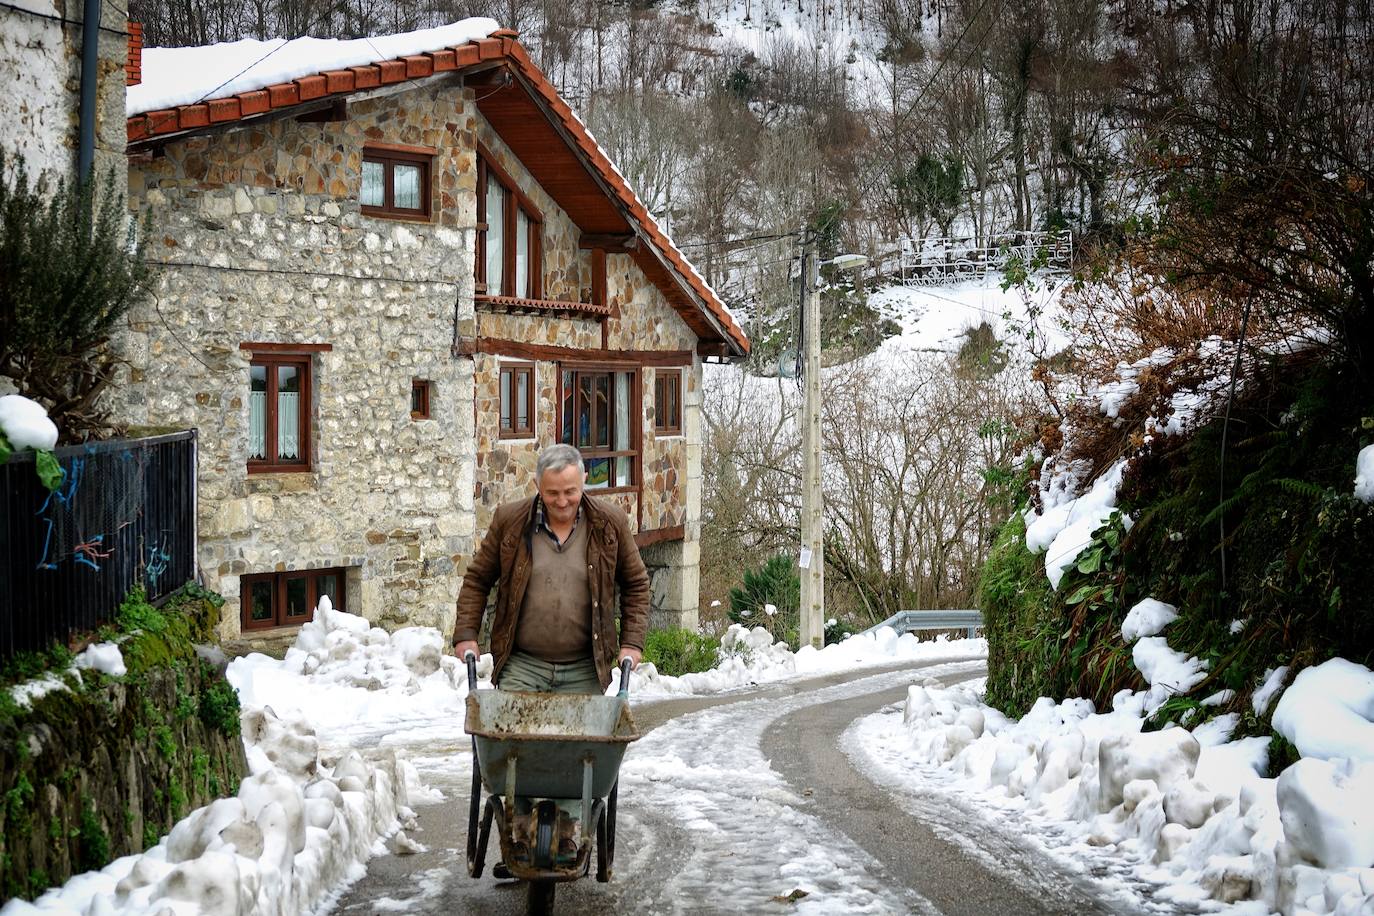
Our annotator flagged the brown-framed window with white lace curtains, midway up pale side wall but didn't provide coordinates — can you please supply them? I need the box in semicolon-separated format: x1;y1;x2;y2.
249;354;311;471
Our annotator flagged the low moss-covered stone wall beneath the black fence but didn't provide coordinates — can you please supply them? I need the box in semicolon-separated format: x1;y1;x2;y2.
0;586;247;900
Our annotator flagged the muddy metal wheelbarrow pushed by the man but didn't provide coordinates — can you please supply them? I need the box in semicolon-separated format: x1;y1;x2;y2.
464;652;639;915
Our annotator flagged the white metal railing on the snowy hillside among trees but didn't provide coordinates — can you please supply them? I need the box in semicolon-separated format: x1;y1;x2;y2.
882;229;1073;286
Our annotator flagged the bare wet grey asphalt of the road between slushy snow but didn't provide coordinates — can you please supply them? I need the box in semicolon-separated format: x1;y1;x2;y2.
328;663;1143;916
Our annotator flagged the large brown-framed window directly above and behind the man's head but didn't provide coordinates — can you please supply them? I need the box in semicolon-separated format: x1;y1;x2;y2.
559;368;639;489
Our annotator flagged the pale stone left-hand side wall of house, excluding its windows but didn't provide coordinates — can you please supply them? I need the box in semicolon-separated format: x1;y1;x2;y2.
118;80;477;639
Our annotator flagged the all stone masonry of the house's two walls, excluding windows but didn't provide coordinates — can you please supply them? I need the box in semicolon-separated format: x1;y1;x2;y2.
113;77;701;641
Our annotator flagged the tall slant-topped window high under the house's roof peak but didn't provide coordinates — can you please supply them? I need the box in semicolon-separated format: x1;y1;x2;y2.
477;150;544;299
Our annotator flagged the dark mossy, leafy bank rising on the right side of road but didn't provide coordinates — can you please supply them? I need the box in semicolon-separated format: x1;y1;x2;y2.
980;358;1374;735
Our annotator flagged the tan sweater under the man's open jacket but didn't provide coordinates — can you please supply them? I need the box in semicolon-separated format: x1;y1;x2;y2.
515;519;592;663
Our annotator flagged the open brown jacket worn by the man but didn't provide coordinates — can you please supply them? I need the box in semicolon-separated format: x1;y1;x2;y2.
453;493;649;688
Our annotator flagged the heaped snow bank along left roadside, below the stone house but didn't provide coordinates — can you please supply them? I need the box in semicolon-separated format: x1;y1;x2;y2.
0;599;475;916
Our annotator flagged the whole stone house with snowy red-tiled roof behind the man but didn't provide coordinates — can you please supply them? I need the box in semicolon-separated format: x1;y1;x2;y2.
118;19;749;644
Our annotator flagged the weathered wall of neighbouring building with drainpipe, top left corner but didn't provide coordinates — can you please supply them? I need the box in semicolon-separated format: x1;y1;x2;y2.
0;0;128;186
